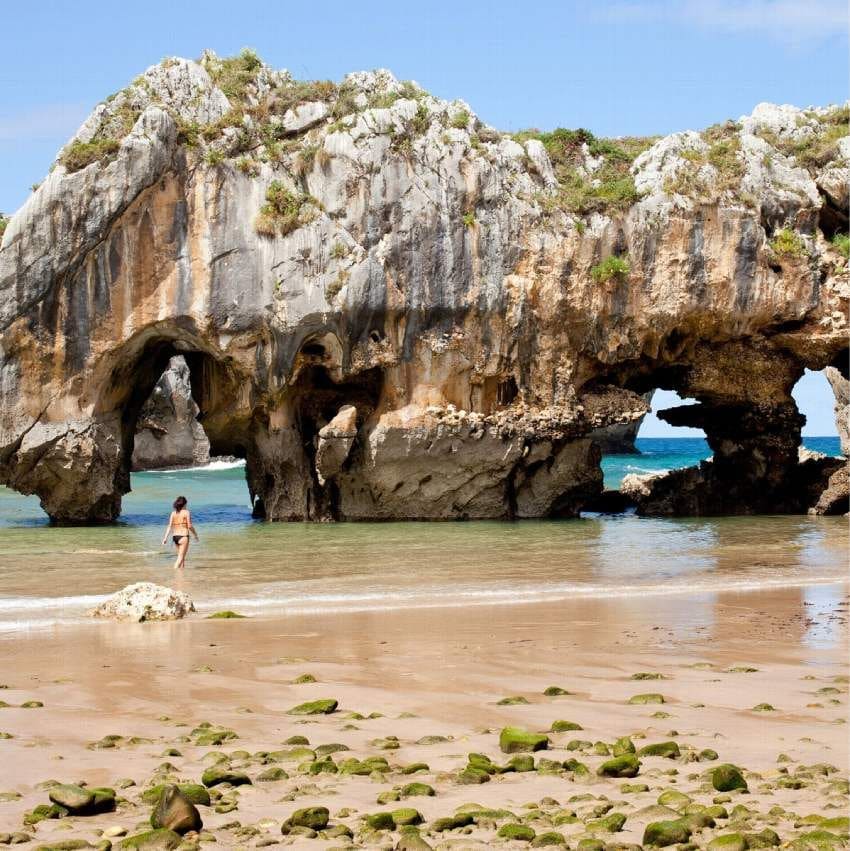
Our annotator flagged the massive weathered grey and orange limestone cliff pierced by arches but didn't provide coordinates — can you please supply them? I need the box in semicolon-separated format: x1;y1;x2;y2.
0;53;850;522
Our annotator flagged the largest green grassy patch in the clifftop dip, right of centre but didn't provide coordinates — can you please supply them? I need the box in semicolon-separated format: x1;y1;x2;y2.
513;127;657;215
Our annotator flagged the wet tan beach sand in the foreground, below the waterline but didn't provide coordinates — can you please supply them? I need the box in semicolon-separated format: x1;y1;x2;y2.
0;585;848;848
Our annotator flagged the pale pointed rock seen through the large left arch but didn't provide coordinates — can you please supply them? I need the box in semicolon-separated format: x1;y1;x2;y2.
132;355;210;470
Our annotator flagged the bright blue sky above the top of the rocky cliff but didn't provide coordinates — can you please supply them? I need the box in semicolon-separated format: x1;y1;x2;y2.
0;0;848;433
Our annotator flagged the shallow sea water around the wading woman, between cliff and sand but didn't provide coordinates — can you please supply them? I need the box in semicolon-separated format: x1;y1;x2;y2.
0;440;848;634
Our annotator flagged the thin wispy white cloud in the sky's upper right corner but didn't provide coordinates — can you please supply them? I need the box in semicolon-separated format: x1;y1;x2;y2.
597;0;848;45
